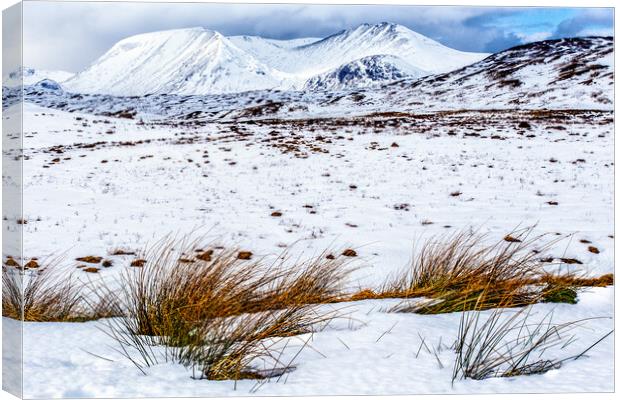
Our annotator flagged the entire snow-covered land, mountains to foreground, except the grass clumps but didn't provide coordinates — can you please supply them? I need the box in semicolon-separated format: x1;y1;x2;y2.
3;24;614;398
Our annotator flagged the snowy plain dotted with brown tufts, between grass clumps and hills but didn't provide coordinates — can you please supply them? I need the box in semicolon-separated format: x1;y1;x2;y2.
9;104;614;286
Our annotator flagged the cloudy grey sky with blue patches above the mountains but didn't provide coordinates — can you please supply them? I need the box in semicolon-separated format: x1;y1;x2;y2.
24;1;613;72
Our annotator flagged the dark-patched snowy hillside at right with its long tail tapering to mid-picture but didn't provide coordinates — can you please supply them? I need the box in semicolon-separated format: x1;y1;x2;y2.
240;37;614;118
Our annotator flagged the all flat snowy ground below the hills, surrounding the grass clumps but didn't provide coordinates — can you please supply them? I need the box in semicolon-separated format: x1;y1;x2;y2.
5;98;614;397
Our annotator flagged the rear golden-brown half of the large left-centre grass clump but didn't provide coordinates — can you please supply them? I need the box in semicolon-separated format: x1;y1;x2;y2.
105;241;351;336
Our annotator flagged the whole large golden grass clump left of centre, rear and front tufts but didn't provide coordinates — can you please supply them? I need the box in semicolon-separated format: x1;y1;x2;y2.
100;239;350;380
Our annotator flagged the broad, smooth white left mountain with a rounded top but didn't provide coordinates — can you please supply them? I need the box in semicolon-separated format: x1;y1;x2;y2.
63;28;283;96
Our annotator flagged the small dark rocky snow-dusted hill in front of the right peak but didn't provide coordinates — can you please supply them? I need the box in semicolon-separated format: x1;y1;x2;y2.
304;55;426;90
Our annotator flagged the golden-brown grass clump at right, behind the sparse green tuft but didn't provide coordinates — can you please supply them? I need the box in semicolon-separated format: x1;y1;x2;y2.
386;229;613;314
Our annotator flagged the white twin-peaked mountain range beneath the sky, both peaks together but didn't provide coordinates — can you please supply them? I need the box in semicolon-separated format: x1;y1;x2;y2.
63;23;487;96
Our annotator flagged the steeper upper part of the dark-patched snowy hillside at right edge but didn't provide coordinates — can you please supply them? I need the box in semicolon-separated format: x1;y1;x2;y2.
377;37;614;109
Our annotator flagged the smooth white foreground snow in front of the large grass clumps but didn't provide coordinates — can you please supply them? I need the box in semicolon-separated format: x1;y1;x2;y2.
3;288;614;398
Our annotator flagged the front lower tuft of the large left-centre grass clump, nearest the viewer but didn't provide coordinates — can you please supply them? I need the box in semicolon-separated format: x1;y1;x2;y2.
109;300;333;381
